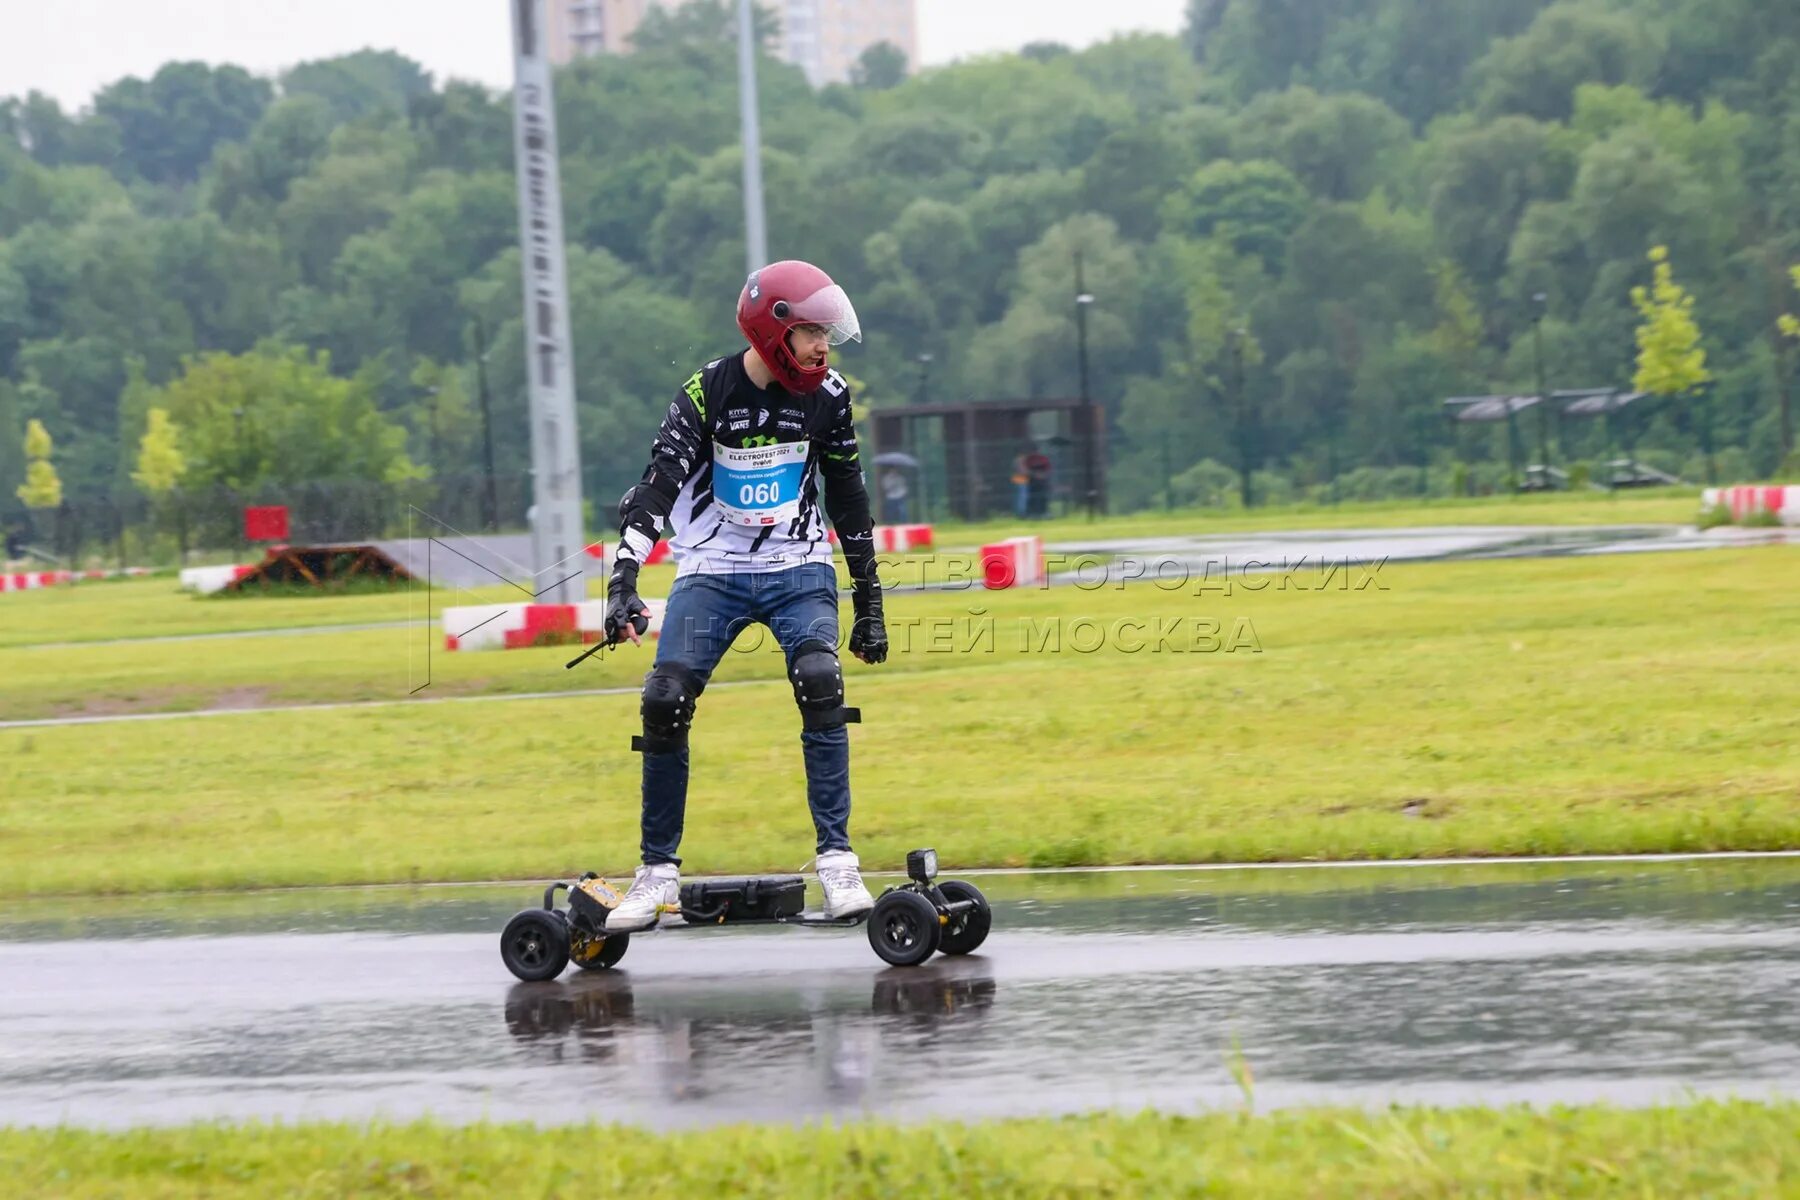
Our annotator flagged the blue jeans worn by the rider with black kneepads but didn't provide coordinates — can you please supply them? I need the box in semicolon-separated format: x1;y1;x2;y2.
639;563;850;865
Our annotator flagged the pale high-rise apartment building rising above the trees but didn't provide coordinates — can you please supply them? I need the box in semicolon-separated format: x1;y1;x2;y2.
547;0;918;88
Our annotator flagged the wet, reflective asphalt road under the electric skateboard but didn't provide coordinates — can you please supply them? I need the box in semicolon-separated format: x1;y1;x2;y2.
0;858;1800;1126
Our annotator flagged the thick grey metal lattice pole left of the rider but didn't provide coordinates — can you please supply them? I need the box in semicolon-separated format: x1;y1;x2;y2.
513;0;587;604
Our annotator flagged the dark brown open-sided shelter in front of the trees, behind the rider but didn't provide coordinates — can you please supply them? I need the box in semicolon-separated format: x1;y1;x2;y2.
869;399;1107;520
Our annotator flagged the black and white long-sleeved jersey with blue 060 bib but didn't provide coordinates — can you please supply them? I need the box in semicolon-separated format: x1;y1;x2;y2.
619;351;875;579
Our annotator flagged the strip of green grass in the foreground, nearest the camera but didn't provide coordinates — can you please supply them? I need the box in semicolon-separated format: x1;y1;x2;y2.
0;1101;1800;1200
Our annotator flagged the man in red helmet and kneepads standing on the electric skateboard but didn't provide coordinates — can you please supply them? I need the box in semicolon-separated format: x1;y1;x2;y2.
605;261;887;932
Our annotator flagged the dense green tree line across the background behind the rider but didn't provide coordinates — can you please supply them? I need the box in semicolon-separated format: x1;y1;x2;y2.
0;0;1800;546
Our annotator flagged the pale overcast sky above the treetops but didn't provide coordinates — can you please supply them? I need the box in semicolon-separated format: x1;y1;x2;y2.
0;0;1186;108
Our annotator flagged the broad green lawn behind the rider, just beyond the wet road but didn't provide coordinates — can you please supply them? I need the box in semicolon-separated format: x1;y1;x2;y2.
0;547;1800;896
